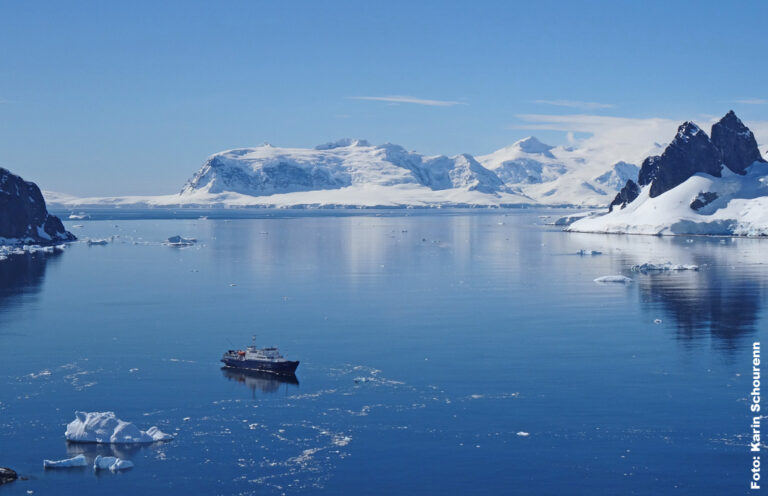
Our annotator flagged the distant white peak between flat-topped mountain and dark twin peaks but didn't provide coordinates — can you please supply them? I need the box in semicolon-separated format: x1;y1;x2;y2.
477;136;639;206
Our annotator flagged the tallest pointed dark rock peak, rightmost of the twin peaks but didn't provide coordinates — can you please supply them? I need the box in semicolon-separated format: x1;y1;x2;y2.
712;110;765;175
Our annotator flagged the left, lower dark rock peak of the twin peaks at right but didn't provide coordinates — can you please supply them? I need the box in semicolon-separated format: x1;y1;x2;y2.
637;122;722;198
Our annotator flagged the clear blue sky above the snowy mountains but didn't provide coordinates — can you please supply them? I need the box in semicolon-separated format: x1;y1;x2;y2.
0;1;768;195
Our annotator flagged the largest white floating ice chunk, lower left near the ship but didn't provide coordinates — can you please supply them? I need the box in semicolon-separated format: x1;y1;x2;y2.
64;412;173;444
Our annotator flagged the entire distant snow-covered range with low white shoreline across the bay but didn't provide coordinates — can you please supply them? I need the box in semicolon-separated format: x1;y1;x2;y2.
47;137;660;208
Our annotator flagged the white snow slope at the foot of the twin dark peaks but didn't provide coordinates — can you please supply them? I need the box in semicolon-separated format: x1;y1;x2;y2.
566;162;768;236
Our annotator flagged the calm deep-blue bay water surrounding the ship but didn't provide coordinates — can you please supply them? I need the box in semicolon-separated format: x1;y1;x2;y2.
0;211;768;495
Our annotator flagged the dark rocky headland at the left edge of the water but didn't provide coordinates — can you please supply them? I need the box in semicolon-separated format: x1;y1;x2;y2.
0;168;77;244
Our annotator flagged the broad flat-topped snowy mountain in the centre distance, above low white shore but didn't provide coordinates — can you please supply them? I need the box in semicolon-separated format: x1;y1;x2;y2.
181;140;504;196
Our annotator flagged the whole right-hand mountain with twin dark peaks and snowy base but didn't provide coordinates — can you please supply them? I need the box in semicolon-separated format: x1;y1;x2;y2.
567;111;768;236
